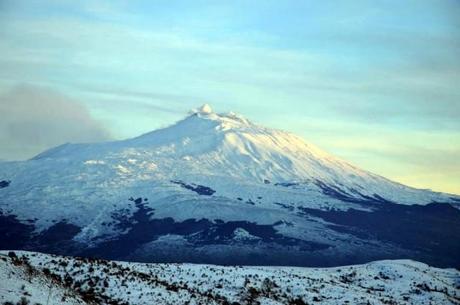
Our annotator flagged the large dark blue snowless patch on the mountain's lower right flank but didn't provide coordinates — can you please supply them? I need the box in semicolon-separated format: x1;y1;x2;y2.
299;203;460;267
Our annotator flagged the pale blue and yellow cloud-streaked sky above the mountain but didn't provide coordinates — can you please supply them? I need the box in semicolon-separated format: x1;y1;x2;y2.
0;0;460;194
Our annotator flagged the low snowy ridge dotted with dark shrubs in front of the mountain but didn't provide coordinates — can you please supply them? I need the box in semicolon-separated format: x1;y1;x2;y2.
0;251;460;305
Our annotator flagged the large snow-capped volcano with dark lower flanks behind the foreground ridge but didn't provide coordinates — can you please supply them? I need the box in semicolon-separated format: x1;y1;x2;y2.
0;105;460;267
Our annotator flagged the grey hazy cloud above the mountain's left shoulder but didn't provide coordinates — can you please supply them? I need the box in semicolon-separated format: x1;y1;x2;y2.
0;85;110;160
